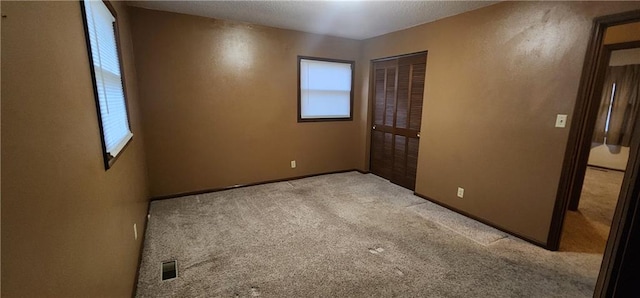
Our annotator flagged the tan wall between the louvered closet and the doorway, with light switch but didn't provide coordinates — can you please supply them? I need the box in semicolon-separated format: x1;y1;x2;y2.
360;2;640;243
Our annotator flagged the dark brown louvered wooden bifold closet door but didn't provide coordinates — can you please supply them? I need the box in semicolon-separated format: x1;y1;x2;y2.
370;52;427;190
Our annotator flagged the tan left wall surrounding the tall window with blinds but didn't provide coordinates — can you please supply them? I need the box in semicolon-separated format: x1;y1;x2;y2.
2;1;148;297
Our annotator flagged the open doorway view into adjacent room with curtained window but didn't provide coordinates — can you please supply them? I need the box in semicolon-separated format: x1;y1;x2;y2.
559;45;640;255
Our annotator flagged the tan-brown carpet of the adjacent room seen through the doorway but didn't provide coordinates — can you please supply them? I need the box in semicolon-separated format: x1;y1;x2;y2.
560;167;624;254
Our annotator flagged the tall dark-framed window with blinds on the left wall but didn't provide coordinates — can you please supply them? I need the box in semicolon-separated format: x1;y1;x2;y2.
80;0;133;169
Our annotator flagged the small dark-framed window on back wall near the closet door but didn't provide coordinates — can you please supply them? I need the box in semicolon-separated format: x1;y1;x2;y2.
298;56;355;122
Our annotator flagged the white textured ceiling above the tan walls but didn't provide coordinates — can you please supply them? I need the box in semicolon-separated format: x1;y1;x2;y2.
129;0;496;40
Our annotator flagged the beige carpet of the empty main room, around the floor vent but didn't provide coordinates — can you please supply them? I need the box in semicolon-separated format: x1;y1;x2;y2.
137;172;601;297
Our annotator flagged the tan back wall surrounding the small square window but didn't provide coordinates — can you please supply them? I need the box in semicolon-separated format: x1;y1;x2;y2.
131;8;362;196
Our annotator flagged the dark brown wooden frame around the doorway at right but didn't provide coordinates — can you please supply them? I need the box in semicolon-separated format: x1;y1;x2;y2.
547;10;640;297
